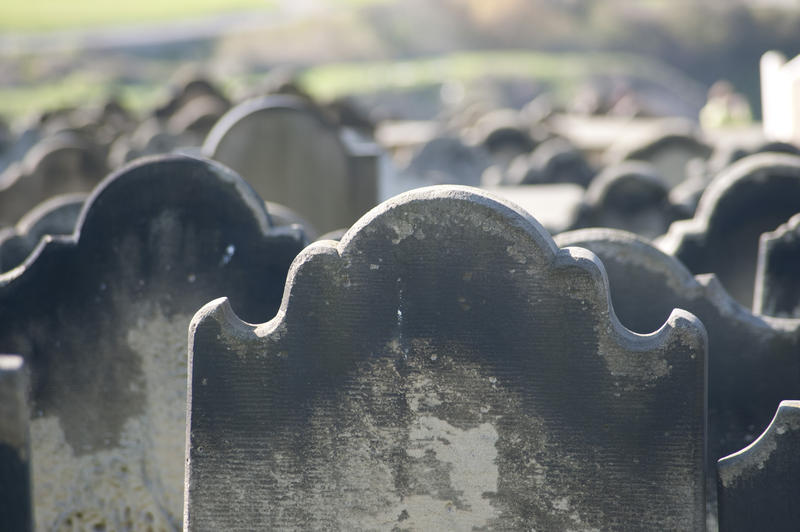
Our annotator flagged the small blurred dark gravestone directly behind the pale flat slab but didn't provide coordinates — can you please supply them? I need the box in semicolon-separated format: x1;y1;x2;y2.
505;138;594;187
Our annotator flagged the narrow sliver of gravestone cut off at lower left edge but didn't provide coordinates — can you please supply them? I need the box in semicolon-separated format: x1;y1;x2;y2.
0;355;33;532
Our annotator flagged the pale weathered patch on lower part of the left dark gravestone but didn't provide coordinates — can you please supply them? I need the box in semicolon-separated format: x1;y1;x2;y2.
31;310;191;532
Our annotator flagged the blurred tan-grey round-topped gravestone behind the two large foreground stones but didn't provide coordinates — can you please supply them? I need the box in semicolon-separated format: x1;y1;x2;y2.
203;95;378;231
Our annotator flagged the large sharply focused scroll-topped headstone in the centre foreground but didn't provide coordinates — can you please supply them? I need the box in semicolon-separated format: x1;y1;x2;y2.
185;186;706;531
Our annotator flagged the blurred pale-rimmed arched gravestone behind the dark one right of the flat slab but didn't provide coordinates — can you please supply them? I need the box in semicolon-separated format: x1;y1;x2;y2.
610;125;712;188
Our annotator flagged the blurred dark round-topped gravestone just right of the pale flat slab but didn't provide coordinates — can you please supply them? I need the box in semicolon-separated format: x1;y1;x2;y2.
575;161;675;238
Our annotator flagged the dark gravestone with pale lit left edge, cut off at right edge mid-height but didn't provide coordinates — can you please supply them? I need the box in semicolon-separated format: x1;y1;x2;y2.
753;214;800;318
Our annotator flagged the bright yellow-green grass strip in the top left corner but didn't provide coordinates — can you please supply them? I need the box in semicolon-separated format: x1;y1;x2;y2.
0;0;276;32
